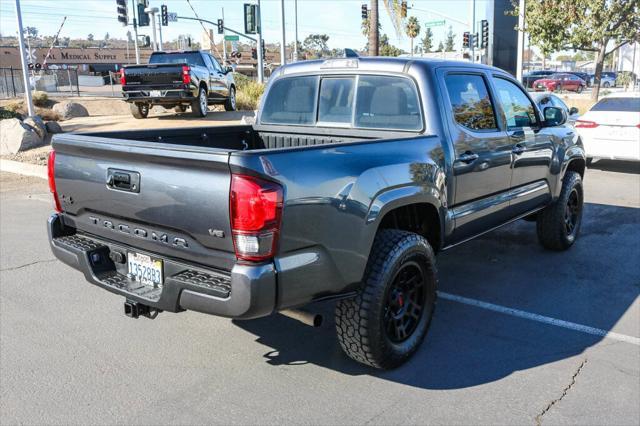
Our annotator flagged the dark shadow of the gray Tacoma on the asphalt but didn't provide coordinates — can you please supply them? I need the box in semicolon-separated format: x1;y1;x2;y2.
234;204;640;389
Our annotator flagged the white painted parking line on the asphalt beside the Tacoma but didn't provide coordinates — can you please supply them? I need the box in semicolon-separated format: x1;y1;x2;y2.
438;291;640;346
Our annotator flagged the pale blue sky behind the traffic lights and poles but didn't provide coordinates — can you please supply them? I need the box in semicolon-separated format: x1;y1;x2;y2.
0;0;487;51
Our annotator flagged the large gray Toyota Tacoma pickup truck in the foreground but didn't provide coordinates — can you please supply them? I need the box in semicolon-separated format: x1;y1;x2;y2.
48;58;585;368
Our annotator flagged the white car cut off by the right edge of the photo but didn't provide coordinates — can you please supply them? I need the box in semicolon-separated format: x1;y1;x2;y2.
575;93;640;161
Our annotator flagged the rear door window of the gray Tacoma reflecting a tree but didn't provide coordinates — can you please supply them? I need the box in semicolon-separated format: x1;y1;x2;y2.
445;74;498;130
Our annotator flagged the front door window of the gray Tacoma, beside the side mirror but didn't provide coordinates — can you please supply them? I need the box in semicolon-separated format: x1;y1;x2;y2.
493;77;538;130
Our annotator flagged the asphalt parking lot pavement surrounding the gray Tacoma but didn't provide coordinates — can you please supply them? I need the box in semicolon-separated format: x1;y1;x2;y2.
0;161;640;425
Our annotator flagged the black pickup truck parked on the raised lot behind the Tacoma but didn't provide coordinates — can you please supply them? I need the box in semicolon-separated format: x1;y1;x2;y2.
120;50;236;118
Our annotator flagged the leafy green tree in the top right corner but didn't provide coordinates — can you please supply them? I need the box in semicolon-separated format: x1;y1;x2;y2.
511;0;640;102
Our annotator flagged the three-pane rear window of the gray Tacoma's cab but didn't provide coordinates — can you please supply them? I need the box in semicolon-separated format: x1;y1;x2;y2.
260;75;423;131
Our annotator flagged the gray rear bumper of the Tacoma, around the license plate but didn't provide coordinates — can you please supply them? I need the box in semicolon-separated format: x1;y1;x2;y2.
48;214;276;319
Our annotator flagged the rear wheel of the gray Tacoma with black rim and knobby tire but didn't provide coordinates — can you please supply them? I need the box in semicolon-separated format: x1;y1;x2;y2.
335;229;437;369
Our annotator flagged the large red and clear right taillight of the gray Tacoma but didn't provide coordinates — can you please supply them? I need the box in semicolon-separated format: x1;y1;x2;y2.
229;175;283;261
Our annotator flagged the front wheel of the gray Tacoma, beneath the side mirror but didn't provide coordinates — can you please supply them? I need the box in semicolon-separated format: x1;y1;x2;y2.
537;171;584;250
